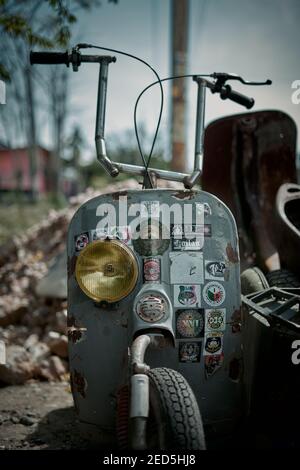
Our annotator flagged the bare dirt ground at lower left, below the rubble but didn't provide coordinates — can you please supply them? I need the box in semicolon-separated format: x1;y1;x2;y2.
0;382;95;450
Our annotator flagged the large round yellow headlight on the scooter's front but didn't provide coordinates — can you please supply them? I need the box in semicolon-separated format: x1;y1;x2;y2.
75;240;138;302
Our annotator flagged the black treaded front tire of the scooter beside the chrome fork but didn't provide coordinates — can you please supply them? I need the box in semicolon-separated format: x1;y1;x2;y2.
148;367;206;451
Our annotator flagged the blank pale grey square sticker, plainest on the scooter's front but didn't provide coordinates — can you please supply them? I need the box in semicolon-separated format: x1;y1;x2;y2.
170;252;204;284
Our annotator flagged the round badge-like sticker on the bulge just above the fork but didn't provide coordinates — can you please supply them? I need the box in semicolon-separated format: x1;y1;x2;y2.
136;293;168;323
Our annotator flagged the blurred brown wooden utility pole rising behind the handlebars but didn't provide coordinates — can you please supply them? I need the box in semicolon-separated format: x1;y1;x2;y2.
171;0;189;172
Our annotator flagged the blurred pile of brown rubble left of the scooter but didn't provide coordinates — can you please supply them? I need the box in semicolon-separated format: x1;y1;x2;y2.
0;180;139;384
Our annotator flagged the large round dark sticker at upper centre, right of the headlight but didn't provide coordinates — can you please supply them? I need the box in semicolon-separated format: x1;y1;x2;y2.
132;219;170;256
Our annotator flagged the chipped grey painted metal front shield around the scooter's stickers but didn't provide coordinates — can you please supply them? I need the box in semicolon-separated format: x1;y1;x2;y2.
67;189;242;440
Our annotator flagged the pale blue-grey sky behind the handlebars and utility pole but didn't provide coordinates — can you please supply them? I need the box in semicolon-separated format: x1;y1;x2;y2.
46;0;300;168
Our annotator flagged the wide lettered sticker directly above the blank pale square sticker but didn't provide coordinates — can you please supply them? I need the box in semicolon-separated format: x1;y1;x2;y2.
171;224;211;251
